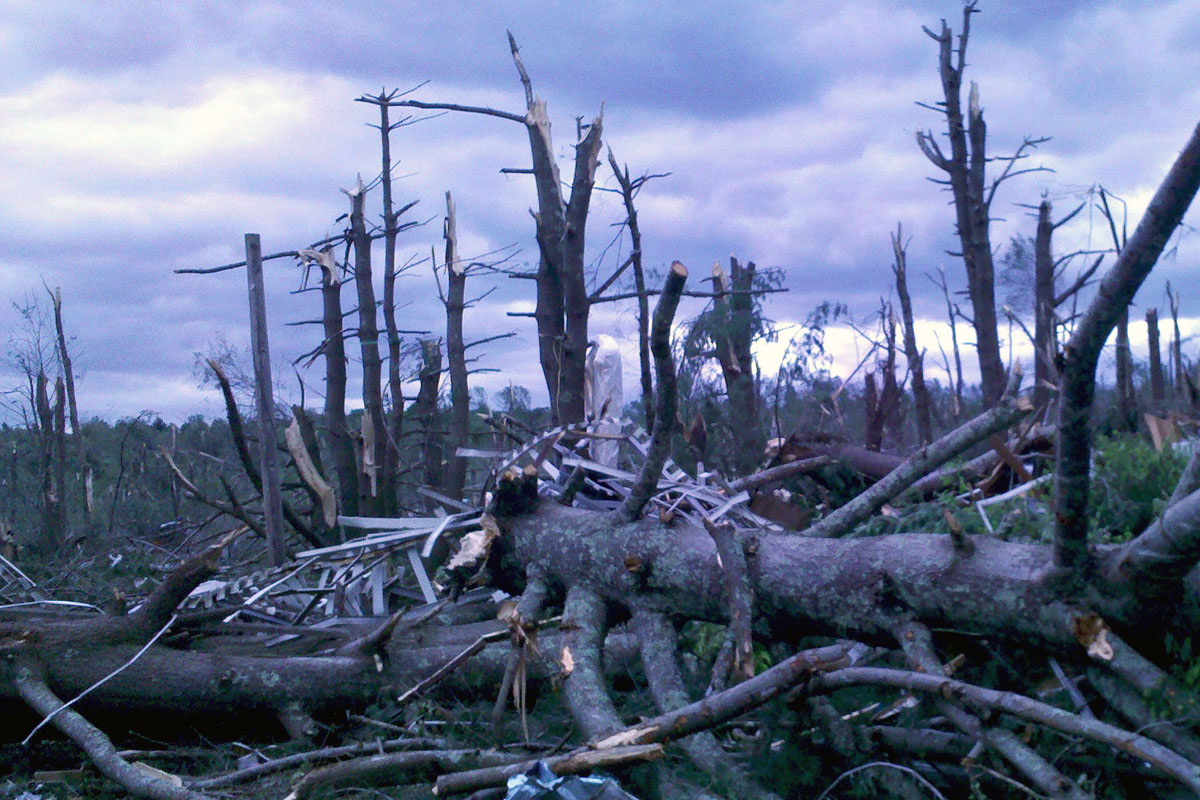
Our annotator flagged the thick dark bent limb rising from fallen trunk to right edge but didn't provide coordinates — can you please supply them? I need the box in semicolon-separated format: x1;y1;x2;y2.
1054;113;1200;579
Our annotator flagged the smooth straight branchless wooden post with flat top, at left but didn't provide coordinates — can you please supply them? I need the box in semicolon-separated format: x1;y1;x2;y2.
246;234;288;566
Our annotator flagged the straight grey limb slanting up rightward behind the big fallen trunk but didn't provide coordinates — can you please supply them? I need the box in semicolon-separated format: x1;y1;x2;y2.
800;365;1033;537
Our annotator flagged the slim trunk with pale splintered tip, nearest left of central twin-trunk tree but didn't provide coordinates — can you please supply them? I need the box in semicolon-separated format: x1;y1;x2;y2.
443;192;470;500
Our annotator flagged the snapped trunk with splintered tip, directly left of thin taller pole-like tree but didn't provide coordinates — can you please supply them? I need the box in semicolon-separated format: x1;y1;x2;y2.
347;179;396;517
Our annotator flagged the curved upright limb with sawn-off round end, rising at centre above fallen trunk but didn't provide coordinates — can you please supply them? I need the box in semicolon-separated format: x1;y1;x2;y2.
614;261;688;522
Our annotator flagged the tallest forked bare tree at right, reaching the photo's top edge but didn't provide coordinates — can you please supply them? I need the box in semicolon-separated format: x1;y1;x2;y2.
917;1;1042;407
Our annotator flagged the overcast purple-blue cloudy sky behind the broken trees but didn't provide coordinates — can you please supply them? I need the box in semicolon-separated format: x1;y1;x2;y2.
0;0;1200;421
